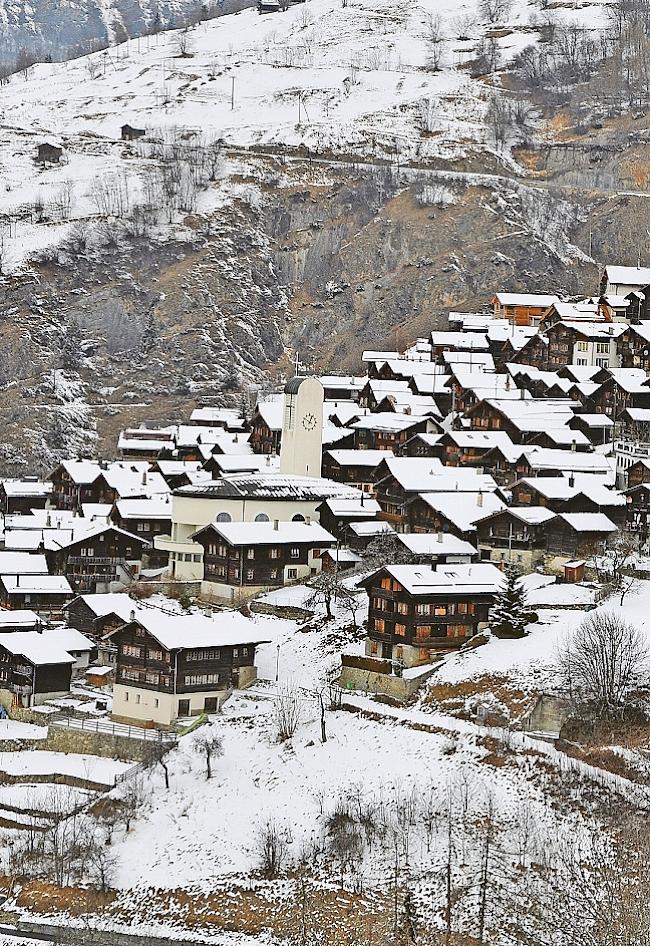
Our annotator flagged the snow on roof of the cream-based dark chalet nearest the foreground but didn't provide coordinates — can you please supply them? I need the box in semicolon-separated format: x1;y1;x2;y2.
123;608;269;650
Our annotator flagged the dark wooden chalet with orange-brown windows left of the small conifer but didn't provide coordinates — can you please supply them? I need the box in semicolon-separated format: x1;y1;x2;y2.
360;564;502;667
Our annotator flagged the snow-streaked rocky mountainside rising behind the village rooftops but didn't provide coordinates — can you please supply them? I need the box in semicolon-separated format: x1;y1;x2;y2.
0;0;648;472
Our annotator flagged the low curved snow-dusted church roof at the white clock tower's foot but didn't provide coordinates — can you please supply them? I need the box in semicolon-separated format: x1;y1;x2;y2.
175;473;361;502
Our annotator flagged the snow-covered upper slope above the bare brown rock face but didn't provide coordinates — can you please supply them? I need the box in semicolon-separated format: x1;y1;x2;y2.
0;0;602;272
